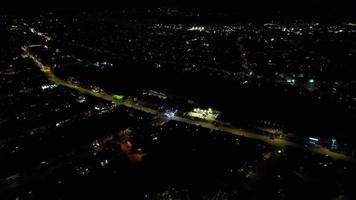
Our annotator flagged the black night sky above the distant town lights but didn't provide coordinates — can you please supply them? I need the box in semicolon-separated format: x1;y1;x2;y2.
1;0;356;20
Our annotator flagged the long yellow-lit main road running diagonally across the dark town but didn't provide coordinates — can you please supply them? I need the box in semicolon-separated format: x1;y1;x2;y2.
22;47;354;162
